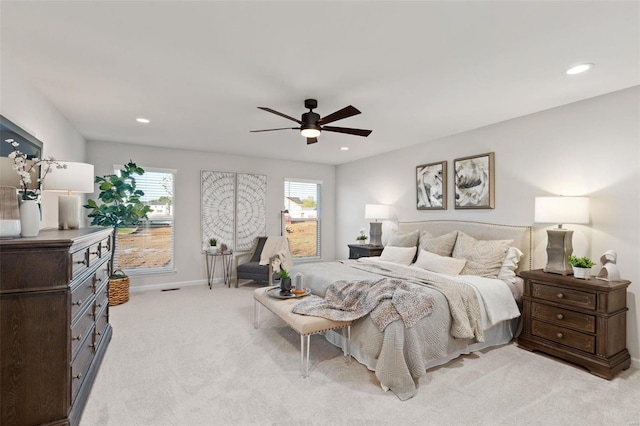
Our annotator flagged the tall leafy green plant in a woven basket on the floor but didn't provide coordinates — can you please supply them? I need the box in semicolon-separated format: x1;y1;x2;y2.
82;160;152;306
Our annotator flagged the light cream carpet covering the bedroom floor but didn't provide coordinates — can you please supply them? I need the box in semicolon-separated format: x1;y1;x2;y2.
81;283;640;426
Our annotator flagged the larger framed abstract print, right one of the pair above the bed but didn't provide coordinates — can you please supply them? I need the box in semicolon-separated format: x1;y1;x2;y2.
453;152;495;209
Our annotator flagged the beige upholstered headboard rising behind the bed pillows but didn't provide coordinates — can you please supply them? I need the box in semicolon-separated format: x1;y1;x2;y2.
398;220;533;271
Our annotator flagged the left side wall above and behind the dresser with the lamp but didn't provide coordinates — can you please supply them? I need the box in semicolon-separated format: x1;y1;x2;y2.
0;61;86;228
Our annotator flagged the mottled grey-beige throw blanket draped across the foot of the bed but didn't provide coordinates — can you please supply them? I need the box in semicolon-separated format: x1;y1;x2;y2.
293;278;434;331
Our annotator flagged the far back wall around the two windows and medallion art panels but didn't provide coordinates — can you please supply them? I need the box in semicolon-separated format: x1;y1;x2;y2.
87;141;335;290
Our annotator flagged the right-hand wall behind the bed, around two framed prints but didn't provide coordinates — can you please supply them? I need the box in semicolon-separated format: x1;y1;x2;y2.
336;86;640;363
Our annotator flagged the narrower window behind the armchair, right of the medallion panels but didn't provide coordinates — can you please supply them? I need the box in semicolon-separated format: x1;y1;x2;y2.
283;179;321;259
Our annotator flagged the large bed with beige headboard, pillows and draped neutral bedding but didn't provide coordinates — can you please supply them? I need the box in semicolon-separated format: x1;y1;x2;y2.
290;221;532;400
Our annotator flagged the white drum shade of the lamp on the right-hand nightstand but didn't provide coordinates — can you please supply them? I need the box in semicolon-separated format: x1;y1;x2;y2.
534;197;589;224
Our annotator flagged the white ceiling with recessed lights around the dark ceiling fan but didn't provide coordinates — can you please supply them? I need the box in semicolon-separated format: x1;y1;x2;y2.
0;0;640;164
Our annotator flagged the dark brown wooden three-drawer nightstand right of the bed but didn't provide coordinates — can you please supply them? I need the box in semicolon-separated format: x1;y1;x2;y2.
518;270;631;380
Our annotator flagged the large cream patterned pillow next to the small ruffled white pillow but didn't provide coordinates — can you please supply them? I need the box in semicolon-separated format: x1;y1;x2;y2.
453;232;513;278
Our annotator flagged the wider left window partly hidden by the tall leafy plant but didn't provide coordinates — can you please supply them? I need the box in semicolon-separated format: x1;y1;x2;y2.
114;166;176;275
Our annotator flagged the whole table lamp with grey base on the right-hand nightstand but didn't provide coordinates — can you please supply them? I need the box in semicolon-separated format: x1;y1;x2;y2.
534;196;589;275
